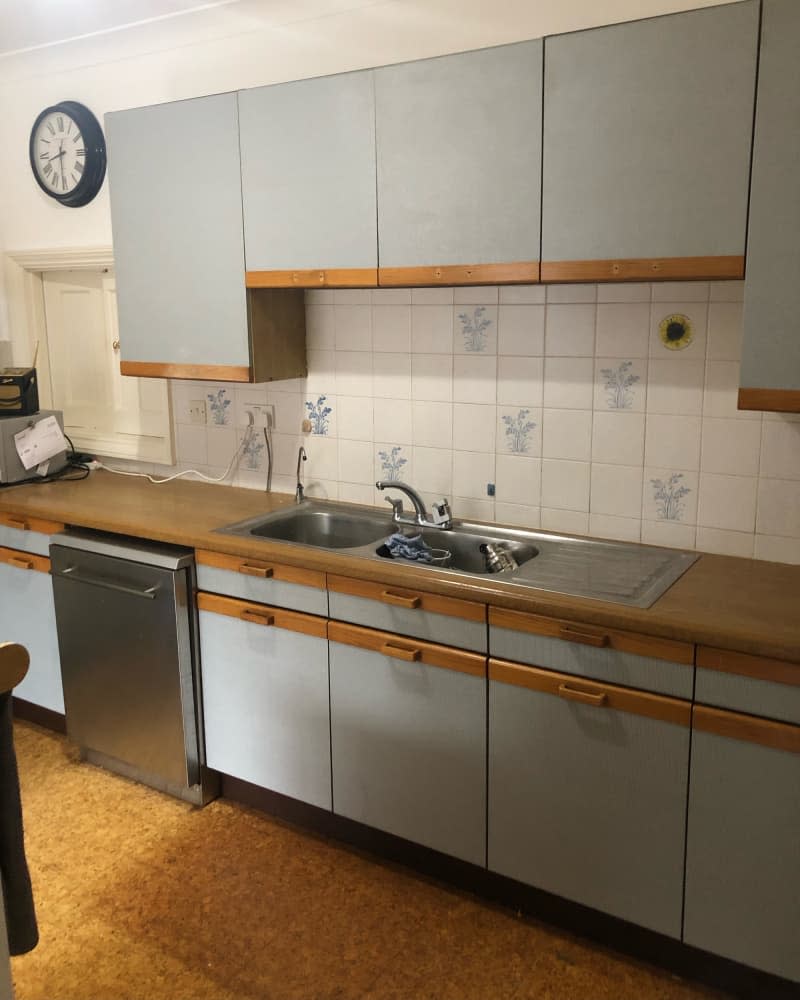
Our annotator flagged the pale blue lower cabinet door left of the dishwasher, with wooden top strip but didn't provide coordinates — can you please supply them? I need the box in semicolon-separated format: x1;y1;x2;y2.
0;548;64;715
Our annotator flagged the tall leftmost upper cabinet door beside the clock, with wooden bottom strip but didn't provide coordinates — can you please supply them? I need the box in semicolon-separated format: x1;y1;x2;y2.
106;94;250;381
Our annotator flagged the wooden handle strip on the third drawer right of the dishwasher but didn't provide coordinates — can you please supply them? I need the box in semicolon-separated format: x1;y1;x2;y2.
489;607;694;666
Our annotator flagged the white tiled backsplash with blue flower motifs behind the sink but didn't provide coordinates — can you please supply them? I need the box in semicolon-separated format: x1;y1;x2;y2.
159;282;800;562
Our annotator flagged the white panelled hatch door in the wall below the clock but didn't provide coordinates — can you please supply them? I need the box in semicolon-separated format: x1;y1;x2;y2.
42;271;174;463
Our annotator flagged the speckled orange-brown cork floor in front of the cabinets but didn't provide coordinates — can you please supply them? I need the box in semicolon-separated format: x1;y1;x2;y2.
7;723;732;1000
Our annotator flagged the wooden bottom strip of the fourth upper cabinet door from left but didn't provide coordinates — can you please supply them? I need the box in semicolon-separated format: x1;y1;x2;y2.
541;257;744;282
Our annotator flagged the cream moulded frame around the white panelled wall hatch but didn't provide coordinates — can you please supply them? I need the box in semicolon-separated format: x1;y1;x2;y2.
3;246;175;465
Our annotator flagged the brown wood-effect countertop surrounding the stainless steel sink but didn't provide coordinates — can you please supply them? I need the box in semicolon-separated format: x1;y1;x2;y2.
0;471;800;661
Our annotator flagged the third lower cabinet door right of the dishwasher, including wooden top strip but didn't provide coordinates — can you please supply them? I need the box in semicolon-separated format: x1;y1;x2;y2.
488;660;690;938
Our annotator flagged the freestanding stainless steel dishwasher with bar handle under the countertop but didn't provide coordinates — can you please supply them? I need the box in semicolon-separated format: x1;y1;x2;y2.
50;531;217;805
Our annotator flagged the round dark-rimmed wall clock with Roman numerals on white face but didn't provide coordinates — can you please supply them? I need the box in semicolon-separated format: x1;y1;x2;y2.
28;101;106;208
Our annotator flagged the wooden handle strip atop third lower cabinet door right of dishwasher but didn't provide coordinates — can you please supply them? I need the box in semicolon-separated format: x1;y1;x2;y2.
489;659;692;727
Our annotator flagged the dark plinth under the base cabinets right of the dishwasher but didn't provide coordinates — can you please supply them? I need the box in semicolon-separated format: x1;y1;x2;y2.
221;774;800;1000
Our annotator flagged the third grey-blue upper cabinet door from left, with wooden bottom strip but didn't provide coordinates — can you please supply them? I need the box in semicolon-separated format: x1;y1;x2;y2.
375;39;542;284
